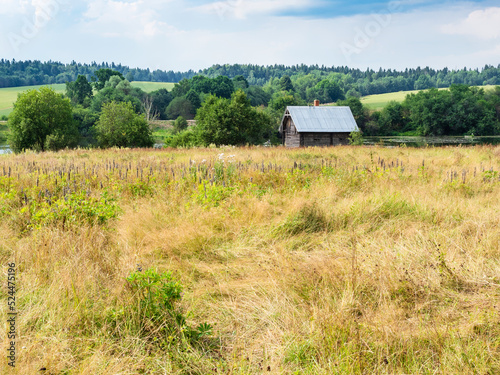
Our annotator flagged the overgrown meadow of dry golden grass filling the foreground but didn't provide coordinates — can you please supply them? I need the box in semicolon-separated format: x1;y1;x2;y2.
0;146;500;374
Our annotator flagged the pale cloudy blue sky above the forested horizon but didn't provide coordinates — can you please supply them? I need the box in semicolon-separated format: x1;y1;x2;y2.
0;0;500;71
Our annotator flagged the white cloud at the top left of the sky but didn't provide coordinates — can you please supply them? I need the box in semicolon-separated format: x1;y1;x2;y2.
82;0;177;40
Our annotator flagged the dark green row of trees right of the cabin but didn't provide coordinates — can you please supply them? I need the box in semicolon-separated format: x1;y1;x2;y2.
337;85;500;136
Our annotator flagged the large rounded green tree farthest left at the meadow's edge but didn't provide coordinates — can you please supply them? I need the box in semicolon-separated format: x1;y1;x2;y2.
9;87;79;152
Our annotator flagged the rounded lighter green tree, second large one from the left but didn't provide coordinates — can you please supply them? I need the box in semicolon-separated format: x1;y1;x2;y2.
96;102;154;147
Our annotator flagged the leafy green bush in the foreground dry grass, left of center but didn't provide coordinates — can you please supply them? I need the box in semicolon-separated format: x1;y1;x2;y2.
126;269;213;347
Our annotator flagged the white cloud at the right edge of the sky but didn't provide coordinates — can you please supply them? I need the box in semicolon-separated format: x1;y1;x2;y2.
442;7;500;39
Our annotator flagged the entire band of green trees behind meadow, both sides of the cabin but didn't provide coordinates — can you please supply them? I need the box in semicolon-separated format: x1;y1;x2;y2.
9;69;500;151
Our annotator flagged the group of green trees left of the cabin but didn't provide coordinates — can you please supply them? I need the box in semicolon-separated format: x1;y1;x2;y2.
8;69;275;152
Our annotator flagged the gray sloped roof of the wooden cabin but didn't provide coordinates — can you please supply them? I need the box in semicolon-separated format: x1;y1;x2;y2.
280;106;359;133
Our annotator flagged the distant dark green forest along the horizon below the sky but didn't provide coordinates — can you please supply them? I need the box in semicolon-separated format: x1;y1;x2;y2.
0;59;500;97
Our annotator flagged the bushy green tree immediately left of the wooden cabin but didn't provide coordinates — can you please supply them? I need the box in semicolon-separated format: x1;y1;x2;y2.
196;90;272;146
